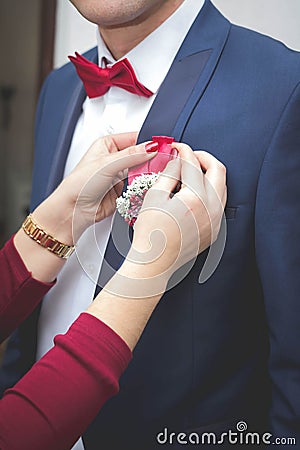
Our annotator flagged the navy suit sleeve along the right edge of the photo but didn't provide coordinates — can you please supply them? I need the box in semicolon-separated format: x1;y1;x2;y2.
255;84;300;445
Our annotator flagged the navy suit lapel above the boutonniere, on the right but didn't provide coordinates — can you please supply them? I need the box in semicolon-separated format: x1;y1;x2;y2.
138;0;230;142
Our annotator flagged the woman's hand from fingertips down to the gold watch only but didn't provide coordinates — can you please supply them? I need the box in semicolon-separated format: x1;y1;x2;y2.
34;132;156;243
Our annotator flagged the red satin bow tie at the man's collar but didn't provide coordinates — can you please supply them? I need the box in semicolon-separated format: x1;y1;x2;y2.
69;52;153;98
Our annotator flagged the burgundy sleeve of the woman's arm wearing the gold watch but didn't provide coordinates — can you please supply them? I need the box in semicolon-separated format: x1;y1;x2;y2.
0;237;55;343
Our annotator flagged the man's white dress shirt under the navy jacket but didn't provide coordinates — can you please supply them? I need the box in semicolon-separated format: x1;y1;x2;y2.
37;0;204;450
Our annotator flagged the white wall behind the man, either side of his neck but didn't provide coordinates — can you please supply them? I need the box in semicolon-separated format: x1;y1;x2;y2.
54;0;300;67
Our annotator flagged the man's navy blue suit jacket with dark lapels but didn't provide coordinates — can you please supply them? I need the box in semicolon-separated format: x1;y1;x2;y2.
2;1;300;450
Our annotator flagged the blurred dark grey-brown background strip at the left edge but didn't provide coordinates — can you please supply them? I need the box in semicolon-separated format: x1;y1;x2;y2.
0;0;41;242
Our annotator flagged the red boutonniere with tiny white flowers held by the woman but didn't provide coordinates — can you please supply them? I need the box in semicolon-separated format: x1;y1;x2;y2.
116;136;177;226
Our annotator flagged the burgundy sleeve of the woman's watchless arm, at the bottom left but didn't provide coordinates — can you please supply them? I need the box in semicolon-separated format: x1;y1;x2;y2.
0;313;132;450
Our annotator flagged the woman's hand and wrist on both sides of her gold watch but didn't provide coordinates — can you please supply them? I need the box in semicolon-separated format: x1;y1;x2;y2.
14;133;156;282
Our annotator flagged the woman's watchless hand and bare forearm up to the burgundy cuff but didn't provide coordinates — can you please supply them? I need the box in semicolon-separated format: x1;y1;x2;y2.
87;143;227;349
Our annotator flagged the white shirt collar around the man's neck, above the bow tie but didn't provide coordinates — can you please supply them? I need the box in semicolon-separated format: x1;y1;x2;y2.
97;0;204;93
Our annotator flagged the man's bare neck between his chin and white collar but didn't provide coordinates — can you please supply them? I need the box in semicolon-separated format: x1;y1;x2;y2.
99;0;184;60
